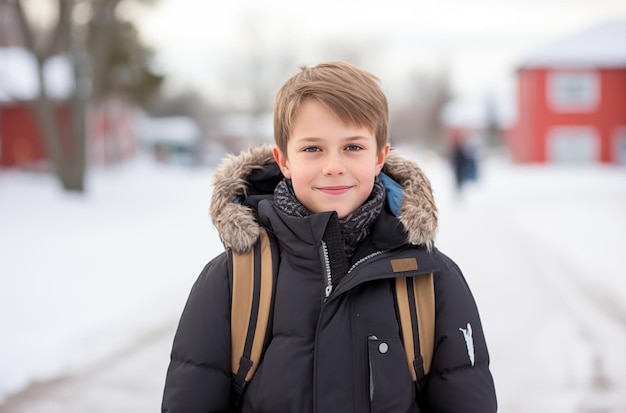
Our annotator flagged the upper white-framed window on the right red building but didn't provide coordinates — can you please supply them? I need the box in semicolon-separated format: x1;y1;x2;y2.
548;72;600;112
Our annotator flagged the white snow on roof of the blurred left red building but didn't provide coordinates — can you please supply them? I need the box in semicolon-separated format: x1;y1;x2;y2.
0;47;74;102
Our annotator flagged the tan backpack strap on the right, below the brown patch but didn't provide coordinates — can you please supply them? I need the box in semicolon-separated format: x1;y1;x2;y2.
396;272;435;384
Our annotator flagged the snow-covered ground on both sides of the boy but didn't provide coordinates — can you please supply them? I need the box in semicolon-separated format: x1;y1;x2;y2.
0;147;626;413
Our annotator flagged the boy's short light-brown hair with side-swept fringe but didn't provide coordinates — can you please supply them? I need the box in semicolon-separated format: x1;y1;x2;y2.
274;61;389;156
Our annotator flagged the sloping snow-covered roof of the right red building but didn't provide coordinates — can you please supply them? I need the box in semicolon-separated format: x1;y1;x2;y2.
521;18;626;68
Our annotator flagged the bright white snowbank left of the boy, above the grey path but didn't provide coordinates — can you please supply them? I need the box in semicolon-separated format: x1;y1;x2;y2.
0;161;220;402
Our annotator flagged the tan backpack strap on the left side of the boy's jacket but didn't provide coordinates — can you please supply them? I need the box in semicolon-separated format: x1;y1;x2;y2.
231;228;278;406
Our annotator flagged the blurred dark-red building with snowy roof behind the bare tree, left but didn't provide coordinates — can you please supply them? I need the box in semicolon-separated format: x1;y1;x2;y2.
0;47;136;167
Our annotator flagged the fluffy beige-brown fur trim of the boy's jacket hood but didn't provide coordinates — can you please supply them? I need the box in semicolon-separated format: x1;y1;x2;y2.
209;146;437;252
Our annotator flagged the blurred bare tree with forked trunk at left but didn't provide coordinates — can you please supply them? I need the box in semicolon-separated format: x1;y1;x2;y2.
5;0;160;192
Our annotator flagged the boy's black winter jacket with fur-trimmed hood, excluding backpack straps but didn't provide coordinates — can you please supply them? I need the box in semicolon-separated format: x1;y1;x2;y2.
162;147;497;413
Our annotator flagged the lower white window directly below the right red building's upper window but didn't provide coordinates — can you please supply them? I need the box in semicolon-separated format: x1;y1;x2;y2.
546;126;600;164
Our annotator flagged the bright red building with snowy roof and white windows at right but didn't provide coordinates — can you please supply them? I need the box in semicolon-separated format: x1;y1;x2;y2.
509;19;626;165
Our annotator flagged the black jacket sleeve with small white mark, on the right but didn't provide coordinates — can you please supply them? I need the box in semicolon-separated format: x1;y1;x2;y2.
423;251;497;413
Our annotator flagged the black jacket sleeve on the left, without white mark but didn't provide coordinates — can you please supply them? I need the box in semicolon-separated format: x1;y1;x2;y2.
161;253;231;413
